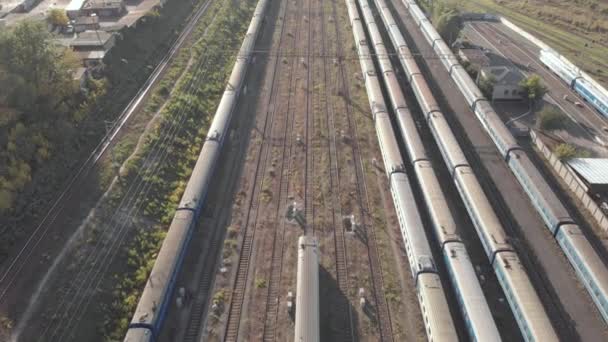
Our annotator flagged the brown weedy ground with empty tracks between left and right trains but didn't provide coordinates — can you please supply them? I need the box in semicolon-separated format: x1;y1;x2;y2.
164;1;432;341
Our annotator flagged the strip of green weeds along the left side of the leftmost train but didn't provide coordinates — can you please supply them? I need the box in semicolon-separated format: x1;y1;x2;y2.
78;0;255;339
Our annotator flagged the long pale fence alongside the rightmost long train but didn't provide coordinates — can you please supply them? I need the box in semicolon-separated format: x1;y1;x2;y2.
530;130;608;233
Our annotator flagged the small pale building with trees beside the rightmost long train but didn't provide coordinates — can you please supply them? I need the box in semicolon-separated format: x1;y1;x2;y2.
477;65;524;101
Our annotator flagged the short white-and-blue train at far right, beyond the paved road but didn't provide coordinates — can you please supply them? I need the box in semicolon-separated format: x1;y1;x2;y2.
539;49;608;118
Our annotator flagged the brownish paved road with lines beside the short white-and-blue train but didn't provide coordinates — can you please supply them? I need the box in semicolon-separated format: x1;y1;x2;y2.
464;22;608;144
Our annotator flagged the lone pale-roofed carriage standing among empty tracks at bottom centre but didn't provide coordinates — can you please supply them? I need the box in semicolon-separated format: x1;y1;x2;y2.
295;235;320;342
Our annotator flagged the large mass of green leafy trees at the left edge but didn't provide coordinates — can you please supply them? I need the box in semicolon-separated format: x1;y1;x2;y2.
0;20;79;213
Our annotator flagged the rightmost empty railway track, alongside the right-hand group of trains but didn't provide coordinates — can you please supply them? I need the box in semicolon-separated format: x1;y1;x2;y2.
333;2;393;341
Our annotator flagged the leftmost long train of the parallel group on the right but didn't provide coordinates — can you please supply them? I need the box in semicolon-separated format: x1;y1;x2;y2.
346;0;458;341
